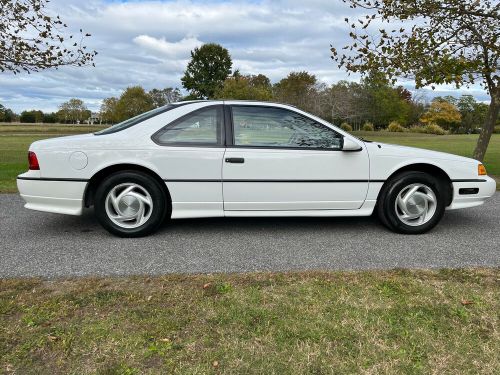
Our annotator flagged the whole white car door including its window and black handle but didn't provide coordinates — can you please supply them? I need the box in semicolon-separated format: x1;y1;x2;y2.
222;105;369;212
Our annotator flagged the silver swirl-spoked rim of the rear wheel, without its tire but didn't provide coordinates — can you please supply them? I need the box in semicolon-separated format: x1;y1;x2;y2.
105;182;153;228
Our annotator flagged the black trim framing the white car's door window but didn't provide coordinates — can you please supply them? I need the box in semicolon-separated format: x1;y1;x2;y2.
229;104;346;151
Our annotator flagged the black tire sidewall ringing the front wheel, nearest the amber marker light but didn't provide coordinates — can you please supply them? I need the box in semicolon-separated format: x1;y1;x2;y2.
384;172;446;234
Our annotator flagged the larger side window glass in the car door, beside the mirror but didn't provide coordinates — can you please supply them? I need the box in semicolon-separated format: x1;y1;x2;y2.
232;106;342;150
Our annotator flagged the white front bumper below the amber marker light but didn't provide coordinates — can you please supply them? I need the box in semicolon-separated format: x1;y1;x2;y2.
446;176;497;210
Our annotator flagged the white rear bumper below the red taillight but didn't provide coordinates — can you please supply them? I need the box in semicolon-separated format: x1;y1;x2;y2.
17;175;87;215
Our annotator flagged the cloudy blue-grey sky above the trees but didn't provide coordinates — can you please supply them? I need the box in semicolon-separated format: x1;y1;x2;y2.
0;0;488;112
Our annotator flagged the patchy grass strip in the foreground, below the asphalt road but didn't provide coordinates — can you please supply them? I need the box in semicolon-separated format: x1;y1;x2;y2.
0;269;500;374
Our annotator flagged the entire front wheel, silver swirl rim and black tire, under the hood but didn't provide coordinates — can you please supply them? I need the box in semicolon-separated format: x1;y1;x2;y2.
377;172;446;234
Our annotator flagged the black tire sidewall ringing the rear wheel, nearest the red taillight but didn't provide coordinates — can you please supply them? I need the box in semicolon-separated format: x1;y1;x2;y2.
94;171;167;237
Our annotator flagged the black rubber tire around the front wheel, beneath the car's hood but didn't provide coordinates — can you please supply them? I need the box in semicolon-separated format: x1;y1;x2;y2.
377;171;448;234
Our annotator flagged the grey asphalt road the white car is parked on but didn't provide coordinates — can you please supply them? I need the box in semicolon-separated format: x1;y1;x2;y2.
0;193;500;278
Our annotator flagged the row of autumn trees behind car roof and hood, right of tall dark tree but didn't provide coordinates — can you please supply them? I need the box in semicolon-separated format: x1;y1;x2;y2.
214;72;488;133
